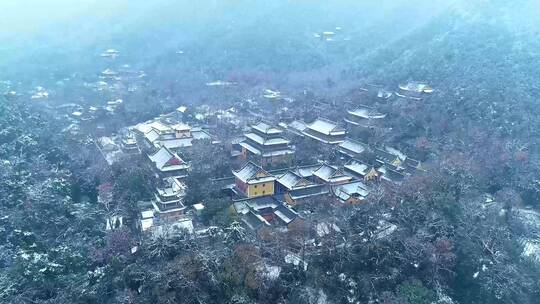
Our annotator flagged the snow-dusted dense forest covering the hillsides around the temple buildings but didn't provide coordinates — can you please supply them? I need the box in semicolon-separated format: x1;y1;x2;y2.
0;0;540;304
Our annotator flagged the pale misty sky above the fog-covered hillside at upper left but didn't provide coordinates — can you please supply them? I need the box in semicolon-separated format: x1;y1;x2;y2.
0;0;452;35
